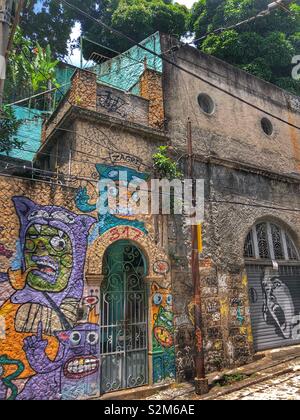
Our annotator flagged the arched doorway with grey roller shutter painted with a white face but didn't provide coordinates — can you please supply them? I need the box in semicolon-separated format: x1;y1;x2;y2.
244;221;300;351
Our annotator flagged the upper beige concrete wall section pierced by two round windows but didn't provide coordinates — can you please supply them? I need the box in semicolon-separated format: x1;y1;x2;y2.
162;37;300;173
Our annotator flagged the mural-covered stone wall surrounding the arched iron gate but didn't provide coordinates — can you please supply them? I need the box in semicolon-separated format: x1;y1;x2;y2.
0;157;175;400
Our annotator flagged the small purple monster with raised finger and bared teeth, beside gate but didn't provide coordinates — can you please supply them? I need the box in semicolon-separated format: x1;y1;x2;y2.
17;323;100;400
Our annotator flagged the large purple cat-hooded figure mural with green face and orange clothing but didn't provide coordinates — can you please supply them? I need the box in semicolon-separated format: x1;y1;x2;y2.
0;197;99;399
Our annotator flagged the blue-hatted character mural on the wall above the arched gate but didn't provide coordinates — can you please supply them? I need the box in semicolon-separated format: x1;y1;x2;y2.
75;164;149;239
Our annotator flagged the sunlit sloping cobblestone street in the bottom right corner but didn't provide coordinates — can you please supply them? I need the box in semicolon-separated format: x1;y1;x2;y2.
145;346;300;401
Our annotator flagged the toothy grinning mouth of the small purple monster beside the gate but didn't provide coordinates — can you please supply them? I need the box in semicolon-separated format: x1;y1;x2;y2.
64;356;99;379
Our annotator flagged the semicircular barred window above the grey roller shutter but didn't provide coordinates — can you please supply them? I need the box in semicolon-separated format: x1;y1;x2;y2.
244;222;300;261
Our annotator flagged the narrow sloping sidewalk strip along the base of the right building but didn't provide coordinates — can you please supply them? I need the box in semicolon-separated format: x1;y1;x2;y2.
146;346;300;401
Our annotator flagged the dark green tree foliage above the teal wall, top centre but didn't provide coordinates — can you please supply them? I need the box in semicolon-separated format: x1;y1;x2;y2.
78;0;189;58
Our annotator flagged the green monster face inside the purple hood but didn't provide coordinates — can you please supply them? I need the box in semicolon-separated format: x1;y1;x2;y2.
25;225;73;293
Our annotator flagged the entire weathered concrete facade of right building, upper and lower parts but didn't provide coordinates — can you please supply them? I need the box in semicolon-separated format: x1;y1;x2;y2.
162;37;300;380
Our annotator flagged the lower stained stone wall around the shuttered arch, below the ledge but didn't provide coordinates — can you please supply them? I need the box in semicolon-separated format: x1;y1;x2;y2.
169;159;300;380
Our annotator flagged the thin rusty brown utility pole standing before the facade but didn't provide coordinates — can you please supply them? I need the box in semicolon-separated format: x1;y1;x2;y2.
187;119;209;395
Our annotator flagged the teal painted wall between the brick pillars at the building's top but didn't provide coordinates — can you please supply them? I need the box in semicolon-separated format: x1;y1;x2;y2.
97;32;162;95
